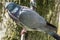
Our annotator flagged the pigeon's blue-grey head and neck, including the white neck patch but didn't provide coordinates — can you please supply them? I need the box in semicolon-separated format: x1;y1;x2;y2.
5;2;21;17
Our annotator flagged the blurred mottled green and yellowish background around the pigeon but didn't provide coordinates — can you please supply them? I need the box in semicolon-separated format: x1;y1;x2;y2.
0;0;59;40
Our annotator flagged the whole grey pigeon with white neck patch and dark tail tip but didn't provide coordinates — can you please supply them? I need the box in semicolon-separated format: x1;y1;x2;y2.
5;2;60;40
